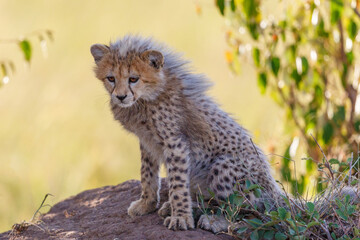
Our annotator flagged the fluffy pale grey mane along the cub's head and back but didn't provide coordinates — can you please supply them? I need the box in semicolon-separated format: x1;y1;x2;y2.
110;35;212;98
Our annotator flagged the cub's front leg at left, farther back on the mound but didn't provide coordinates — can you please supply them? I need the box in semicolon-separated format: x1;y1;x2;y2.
128;146;160;217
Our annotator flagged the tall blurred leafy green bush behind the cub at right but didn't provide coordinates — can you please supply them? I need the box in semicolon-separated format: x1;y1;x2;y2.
215;0;360;193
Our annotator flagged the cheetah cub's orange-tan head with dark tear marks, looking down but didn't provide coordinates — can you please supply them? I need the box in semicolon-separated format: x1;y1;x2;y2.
90;44;165;108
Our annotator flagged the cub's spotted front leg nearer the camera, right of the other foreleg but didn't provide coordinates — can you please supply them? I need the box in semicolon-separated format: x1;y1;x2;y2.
164;138;194;230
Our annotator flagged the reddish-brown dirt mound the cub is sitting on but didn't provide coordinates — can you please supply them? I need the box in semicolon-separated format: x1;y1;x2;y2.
0;180;232;240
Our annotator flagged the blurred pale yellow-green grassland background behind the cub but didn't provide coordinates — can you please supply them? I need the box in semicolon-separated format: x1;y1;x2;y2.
0;0;283;232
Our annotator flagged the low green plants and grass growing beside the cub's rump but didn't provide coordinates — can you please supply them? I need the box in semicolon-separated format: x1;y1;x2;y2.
199;153;360;240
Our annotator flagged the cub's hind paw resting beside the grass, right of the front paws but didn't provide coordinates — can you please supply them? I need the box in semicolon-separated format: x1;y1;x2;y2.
197;214;230;233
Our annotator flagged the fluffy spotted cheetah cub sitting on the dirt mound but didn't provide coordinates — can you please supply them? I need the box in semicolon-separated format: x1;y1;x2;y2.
91;35;281;232
